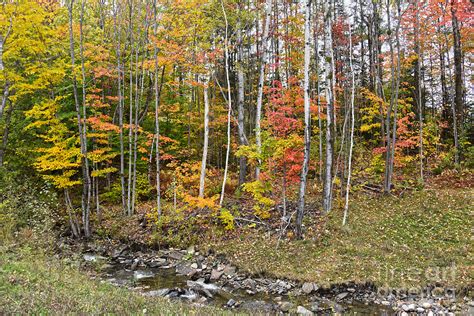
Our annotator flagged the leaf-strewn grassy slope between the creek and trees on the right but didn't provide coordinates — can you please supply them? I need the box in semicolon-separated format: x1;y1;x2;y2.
213;189;474;288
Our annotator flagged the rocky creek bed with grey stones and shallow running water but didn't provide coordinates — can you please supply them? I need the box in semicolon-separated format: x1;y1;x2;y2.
70;244;474;315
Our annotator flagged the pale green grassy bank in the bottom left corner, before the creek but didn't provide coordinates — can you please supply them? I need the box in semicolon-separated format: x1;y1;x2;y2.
0;242;230;315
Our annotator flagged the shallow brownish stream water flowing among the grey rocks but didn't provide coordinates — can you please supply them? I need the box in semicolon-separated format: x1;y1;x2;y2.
102;264;395;315
